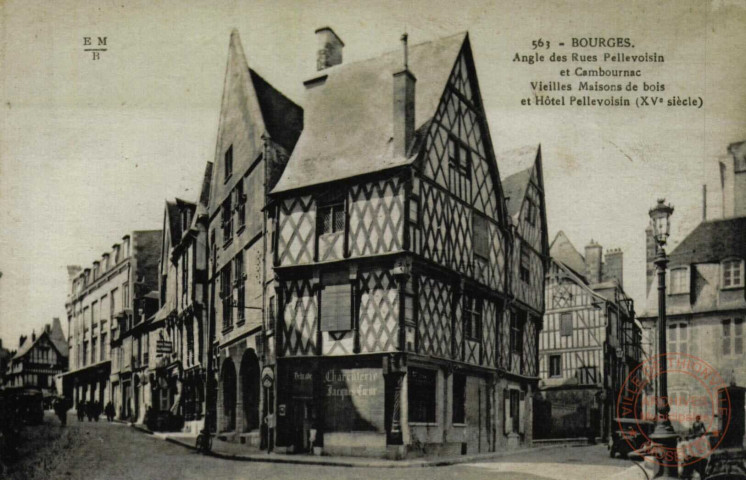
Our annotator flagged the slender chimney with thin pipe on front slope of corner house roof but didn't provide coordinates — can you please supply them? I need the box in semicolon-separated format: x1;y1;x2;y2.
393;33;417;157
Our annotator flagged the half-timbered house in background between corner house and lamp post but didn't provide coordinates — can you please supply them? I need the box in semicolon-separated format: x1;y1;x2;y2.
534;231;642;438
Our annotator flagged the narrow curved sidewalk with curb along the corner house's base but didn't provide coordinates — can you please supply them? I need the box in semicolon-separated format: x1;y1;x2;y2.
155;435;567;468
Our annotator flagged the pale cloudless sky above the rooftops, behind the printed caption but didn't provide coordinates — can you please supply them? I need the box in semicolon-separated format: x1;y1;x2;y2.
0;0;746;348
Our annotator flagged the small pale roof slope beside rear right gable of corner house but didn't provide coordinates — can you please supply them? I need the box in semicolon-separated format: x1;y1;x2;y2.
497;145;539;217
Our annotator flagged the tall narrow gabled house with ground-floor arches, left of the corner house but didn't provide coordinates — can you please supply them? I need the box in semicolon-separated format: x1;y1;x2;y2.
207;31;303;446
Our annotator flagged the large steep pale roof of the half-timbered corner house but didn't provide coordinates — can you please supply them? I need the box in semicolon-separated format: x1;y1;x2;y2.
273;33;468;193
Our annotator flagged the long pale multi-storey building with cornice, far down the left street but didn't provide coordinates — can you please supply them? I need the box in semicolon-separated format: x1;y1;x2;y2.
63;230;161;418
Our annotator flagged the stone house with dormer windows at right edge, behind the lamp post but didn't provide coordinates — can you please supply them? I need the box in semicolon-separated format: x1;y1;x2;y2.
640;142;746;431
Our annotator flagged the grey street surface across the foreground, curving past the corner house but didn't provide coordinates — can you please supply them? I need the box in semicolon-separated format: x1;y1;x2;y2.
5;416;643;480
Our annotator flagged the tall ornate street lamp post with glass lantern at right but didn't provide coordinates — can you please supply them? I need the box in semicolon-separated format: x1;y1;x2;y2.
649;198;679;478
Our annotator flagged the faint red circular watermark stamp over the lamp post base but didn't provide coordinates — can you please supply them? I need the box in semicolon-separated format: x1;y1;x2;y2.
616;352;732;467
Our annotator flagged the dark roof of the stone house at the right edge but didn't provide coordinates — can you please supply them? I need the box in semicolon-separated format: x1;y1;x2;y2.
669;217;746;266
